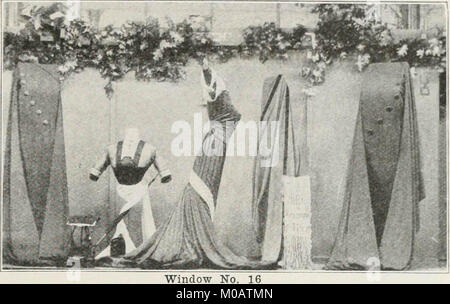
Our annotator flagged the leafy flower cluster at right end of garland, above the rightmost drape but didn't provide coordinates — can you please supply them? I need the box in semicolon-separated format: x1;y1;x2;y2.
301;4;446;85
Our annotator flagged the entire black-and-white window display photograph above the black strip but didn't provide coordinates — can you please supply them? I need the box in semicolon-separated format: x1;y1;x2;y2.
1;1;450;284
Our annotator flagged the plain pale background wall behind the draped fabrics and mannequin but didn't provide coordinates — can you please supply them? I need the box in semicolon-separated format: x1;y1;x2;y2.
3;54;439;268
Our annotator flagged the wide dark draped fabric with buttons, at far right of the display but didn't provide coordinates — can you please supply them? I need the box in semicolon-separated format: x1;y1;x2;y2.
328;63;424;270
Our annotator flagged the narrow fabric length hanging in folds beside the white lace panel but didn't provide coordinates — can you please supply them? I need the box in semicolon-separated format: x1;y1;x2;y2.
252;75;300;262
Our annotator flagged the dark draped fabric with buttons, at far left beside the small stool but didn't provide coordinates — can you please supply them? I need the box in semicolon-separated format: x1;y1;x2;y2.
3;63;69;264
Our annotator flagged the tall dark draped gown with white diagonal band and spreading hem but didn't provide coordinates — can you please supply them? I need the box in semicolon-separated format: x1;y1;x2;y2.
114;78;269;269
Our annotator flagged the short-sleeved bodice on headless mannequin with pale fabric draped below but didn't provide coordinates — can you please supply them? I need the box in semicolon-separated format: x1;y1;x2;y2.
90;140;171;259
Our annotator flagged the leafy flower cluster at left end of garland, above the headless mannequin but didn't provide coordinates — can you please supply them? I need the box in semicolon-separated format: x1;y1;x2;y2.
4;3;214;97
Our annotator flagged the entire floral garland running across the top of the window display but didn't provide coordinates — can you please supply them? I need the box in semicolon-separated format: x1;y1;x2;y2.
4;3;446;97
